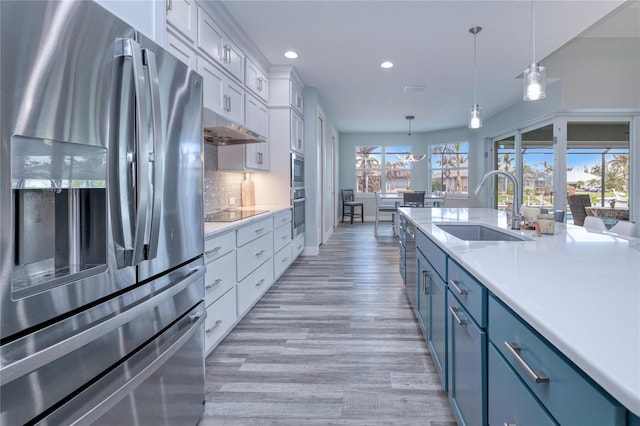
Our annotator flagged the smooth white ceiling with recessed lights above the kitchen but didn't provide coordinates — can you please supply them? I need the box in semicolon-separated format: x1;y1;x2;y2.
221;0;640;132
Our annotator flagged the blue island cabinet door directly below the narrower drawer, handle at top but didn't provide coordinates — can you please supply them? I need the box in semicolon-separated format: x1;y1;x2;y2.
447;290;487;426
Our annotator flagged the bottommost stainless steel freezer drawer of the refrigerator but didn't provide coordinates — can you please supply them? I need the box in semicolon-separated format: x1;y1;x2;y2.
42;302;206;426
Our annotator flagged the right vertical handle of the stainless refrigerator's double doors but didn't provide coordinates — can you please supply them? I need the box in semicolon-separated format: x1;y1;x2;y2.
142;49;164;259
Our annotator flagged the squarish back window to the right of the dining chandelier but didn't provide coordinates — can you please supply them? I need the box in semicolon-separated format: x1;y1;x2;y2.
431;141;469;195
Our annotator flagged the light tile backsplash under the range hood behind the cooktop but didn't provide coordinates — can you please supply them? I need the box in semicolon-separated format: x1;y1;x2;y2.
204;143;243;213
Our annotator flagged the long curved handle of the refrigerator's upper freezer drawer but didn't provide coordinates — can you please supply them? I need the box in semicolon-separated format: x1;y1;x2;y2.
0;266;206;385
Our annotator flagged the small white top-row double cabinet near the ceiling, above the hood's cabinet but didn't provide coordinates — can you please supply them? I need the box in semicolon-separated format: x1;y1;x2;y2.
197;8;245;82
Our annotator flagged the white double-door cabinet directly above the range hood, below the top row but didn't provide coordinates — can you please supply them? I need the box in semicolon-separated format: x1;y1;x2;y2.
198;57;244;124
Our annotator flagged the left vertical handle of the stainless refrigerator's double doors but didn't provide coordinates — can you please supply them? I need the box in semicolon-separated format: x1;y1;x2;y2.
110;38;150;268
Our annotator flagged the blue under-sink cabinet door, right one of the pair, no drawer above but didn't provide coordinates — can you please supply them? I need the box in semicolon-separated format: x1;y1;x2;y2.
428;268;449;392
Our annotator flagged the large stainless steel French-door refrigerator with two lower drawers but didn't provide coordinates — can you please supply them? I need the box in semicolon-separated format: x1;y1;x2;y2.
0;0;205;426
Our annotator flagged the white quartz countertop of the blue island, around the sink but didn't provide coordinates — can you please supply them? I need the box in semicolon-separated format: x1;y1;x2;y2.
401;208;640;416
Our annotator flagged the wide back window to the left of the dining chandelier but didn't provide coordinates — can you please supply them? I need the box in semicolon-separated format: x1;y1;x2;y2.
355;146;411;193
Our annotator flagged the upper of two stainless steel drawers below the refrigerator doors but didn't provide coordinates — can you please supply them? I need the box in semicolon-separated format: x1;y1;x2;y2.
0;259;204;425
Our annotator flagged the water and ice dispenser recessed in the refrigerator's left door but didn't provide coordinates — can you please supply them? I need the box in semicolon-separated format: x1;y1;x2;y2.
11;136;108;298
